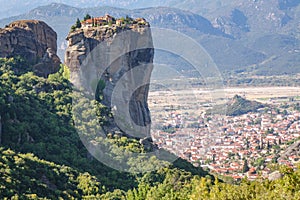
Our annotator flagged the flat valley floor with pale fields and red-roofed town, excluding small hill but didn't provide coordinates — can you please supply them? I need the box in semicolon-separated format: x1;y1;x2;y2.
149;87;300;179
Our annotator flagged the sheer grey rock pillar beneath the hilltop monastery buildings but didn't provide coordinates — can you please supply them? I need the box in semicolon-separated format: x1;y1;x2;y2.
65;23;154;138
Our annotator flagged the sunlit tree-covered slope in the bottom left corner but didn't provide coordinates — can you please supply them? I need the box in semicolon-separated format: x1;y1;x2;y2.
0;148;102;199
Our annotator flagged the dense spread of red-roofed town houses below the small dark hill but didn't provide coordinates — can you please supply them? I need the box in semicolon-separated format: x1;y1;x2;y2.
152;106;300;179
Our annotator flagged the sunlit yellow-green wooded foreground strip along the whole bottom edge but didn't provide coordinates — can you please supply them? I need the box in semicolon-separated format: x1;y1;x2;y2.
0;141;299;200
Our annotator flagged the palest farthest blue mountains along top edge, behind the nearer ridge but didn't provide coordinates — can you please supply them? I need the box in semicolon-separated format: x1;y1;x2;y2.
0;0;300;37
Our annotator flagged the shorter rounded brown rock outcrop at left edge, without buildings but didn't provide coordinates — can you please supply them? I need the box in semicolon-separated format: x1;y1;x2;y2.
0;20;60;76
